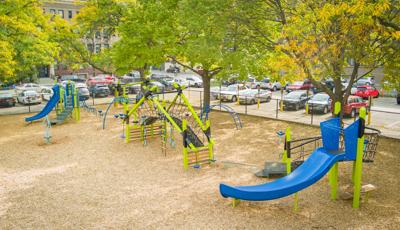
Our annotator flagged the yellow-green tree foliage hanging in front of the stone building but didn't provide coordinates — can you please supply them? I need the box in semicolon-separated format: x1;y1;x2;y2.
53;0;127;74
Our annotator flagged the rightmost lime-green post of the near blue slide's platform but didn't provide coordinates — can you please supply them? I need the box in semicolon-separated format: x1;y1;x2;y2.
353;107;366;208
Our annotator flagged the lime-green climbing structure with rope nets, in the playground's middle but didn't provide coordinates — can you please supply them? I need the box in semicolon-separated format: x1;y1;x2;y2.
124;84;214;169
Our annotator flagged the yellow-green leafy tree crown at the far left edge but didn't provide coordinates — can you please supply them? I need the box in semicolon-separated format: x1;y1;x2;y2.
0;0;59;81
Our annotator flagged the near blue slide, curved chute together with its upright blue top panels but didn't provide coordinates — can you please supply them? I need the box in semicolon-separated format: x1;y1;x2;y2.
219;118;360;201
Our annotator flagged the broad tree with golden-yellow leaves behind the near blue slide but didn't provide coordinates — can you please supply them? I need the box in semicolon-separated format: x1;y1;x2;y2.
237;0;399;114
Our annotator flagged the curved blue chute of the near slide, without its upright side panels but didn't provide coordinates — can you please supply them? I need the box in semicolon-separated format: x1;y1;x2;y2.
219;147;345;201
